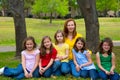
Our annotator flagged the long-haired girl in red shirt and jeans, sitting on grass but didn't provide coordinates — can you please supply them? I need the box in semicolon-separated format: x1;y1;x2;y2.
39;36;57;77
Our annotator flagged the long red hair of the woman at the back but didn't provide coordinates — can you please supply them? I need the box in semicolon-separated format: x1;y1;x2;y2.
63;18;77;38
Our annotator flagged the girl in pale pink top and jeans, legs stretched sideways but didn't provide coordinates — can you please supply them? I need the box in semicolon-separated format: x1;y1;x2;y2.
0;37;40;79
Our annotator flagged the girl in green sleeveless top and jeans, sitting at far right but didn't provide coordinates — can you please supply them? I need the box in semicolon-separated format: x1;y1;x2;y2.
96;38;119;80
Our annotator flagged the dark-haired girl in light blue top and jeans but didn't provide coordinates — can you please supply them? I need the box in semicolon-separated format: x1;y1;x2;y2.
72;37;97;80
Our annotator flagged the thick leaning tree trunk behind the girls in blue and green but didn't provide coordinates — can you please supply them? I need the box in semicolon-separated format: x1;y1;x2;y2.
77;0;99;53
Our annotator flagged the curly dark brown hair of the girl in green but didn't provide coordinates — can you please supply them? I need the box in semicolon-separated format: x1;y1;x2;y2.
99;37;113;55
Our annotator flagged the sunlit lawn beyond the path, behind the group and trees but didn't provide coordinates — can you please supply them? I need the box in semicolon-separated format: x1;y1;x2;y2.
0;17;120;46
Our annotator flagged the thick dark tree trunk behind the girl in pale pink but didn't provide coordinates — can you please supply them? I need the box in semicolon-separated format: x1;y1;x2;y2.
9;0;27;57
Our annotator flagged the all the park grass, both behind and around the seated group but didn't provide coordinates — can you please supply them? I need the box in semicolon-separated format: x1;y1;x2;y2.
0;17;120;80
